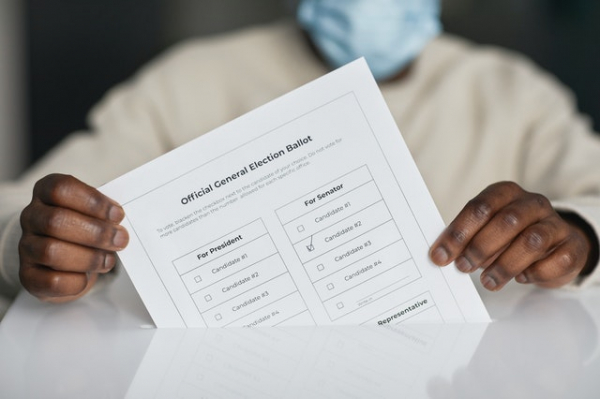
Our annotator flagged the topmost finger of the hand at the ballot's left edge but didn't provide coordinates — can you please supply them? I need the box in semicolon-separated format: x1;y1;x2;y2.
33;174;125;223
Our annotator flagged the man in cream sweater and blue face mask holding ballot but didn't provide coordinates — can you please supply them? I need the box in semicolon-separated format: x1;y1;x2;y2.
0;0;600;310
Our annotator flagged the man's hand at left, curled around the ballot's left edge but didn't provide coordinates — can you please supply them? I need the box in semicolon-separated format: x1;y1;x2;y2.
19;174;129;302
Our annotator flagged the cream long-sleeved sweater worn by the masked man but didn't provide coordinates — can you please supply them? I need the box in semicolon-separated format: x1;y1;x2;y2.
0;22;600;310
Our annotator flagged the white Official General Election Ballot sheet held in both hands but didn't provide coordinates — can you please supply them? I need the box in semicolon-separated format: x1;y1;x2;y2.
101;59;489;327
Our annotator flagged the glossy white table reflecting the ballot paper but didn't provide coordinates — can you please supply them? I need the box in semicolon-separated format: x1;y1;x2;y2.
0;273;600;399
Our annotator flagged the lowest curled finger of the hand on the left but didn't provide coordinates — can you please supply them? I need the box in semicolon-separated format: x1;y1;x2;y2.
19;263;97;300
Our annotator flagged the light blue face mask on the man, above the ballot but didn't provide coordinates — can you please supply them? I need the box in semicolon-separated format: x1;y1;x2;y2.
297;0;441;81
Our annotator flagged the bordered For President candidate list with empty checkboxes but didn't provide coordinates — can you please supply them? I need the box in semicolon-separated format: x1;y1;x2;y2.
172;219;307;327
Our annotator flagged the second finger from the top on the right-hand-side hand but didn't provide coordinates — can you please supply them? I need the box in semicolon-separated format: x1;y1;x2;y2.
456;194;556;273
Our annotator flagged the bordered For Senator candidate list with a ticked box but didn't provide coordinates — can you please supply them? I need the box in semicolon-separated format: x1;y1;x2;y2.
276;165;422;321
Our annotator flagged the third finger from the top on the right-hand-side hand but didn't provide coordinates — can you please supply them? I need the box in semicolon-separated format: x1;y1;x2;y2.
480;218;569;291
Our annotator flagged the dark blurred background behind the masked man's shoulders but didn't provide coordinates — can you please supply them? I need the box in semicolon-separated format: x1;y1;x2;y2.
0;0;600;180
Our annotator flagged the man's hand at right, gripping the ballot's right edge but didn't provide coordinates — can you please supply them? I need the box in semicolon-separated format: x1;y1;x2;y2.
430;182;596;291
